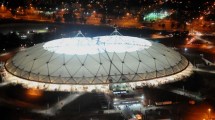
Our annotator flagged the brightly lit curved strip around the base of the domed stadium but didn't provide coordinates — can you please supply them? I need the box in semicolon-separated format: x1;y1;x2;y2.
3;63;193;92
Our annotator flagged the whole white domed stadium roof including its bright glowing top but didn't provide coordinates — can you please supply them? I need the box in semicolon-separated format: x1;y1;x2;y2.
5;35;189;85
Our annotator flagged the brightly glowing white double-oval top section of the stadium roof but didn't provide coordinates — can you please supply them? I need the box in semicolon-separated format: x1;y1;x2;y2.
43;30;151;55
